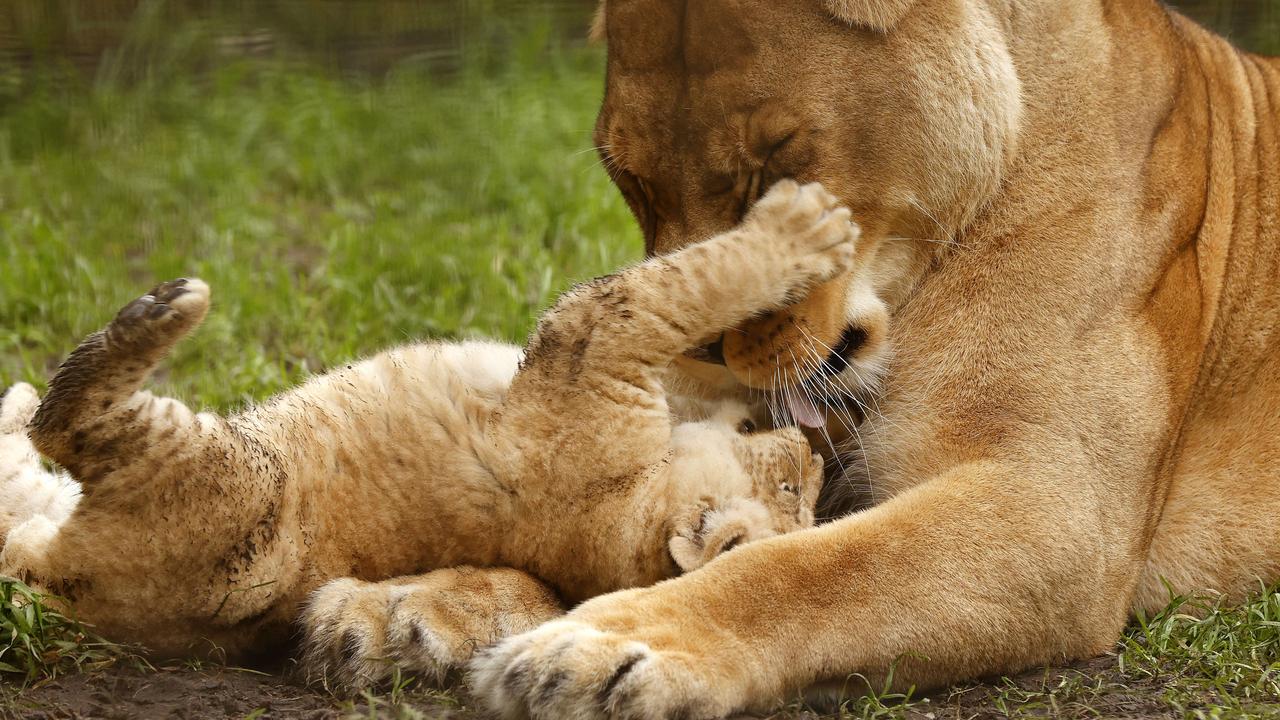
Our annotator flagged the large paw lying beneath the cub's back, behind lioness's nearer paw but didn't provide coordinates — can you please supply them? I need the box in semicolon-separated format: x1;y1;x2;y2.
300;568;564;688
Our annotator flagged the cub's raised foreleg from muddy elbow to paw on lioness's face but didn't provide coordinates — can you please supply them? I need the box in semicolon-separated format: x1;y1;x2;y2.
519;179;860;366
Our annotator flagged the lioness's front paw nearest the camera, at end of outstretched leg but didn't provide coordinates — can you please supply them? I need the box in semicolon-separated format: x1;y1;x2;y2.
471;619;735;720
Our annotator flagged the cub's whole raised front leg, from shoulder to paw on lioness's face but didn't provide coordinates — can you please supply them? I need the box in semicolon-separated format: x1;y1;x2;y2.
497;181;859;478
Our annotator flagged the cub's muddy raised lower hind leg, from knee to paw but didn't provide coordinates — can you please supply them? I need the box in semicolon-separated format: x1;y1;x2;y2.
31;279;209;483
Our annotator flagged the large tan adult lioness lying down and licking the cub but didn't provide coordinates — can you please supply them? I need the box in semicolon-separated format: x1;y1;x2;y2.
476;0;1280;719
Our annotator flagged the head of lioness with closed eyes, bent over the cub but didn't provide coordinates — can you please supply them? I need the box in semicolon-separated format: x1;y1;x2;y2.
595;0;1020;424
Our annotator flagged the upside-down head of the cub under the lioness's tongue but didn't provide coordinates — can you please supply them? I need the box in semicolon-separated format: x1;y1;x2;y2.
667;402;822;573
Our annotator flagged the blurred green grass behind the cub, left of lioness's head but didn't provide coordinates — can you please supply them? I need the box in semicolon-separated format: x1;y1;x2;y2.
0;7;641;409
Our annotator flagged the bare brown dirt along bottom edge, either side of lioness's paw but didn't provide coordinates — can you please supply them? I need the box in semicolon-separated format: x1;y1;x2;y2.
0;659;1185;720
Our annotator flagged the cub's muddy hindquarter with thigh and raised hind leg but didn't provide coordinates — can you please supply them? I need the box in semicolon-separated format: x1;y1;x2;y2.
10;279;307;655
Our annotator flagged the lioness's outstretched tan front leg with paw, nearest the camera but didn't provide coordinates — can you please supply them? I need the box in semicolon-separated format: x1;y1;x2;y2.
472;465;1141;720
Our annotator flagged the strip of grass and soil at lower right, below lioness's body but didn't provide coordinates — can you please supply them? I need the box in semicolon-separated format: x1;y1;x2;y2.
803;588;1280;720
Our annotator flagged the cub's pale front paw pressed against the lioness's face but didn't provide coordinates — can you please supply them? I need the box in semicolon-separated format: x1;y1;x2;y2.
744;179;861;284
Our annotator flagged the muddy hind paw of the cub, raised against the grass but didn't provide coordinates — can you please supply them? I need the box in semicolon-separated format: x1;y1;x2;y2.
106;278;209;350
